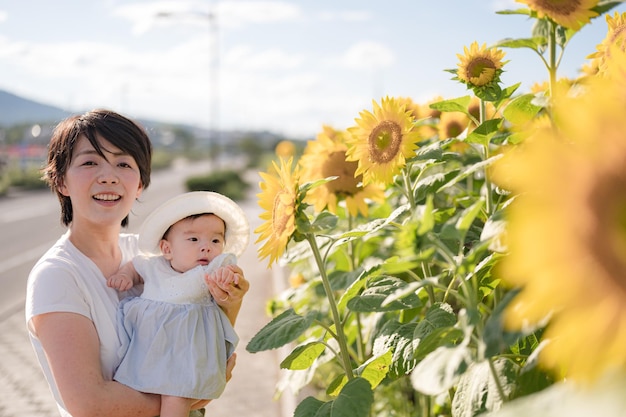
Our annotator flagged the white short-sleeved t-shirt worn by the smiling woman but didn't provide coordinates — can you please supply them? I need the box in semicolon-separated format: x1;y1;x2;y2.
25;233;142;417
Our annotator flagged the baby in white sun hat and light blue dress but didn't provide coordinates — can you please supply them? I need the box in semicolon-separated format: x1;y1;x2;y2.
107;191;250;417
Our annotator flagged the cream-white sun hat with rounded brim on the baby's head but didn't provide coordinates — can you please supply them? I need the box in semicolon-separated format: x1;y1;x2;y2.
139;191;250;257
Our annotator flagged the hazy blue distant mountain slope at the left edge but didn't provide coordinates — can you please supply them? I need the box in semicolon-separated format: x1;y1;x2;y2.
0;90;71;126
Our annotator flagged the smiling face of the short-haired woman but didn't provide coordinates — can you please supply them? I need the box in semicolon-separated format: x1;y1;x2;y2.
59;136;143;226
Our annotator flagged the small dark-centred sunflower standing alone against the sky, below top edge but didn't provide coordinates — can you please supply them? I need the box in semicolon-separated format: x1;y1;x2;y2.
456;42;504;87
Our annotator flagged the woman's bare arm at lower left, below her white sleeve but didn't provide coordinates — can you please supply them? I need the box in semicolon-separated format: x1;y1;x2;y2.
31;313;160;417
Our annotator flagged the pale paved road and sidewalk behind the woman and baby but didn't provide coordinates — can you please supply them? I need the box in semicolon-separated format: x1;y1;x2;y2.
0;158;295;417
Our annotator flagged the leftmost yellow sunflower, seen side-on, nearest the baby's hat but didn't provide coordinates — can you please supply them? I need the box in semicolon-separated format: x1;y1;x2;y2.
254;158;298;267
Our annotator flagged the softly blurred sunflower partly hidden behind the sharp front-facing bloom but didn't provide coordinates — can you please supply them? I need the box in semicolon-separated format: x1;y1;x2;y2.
300;126;385;216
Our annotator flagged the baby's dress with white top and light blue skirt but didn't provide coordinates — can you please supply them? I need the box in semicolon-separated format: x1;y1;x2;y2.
113;254;239;400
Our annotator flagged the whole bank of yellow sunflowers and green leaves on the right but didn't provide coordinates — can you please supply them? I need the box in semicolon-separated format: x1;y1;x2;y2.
246;0;626;417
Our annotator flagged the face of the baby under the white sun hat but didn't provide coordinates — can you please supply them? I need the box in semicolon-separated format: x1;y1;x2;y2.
161;214;225;272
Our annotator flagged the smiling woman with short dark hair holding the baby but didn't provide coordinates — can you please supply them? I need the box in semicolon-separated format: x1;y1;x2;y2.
26;110;249;417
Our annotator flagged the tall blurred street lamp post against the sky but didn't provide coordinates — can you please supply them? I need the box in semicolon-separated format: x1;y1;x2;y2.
156;1;220;169
